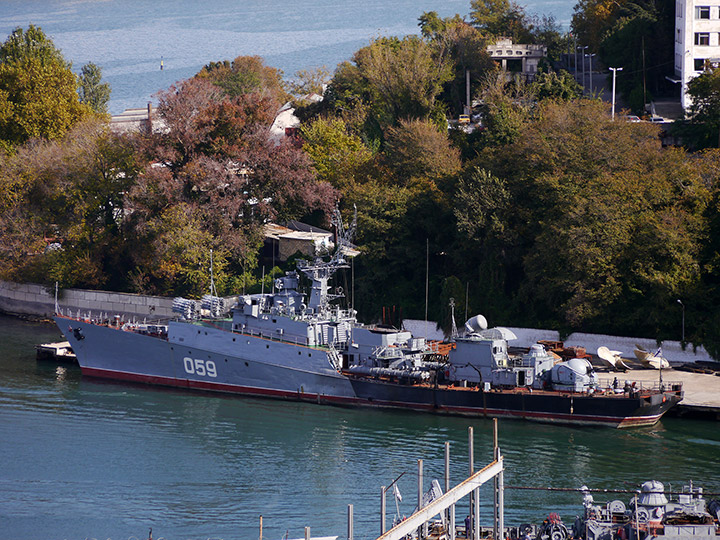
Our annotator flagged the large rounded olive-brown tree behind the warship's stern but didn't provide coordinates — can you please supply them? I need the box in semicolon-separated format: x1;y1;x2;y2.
478;100;708;337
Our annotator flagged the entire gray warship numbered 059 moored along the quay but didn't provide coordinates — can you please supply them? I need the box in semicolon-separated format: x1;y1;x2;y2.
55;211;683;427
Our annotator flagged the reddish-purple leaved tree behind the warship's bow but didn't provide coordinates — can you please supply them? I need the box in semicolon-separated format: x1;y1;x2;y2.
130;77;336;285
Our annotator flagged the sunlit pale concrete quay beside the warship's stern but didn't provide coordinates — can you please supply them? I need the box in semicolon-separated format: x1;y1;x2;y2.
598;369;720;420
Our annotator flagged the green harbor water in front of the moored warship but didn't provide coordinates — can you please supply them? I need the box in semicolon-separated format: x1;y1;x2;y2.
0;316;720;540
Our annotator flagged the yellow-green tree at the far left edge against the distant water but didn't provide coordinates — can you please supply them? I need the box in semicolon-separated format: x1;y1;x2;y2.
0;25;91;147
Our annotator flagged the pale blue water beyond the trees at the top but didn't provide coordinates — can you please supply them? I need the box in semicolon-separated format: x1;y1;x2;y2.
0;0;575;113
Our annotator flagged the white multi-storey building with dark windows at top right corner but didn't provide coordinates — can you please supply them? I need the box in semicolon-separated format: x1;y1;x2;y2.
675;0;720;110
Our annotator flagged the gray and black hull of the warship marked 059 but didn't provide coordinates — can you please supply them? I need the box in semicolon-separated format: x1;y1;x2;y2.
55;316;682;428
